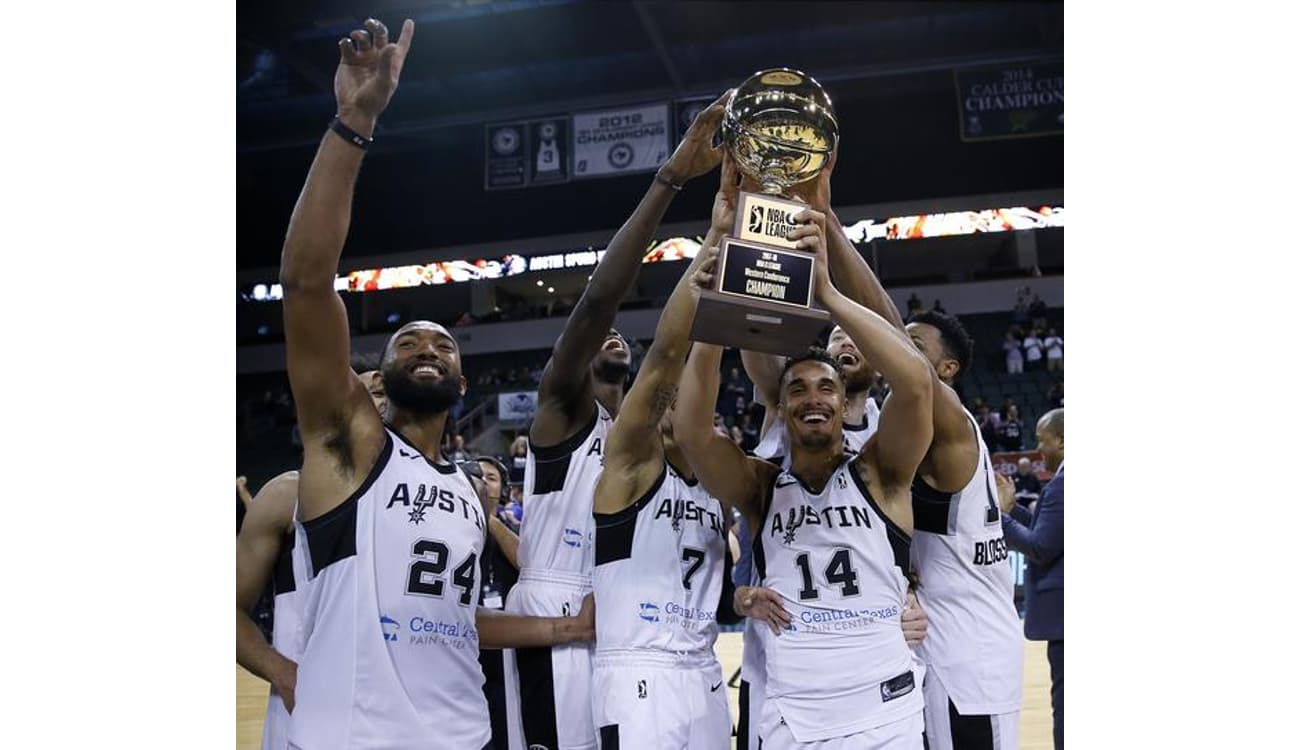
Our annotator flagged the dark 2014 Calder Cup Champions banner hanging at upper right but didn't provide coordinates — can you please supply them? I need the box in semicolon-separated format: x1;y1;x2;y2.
953;60;1065;142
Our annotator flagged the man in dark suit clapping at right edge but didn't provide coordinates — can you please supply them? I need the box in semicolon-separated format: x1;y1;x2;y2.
997;408;1065;750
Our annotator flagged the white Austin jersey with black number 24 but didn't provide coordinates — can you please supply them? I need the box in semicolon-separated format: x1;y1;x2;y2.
289;429;491;750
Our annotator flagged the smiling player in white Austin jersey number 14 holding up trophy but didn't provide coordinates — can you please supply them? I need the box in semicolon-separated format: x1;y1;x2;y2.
673;209;933;750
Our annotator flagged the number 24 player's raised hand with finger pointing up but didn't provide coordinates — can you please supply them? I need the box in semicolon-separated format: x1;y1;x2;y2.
334;18;415;135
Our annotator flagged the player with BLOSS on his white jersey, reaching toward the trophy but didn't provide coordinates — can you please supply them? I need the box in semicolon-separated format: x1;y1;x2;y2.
780;188;1023;750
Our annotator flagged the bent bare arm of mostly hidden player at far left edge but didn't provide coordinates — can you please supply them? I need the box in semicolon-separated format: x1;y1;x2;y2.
235;472;298;712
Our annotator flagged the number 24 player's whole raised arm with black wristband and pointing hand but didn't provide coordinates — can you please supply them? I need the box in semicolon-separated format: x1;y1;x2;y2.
280;19;415;519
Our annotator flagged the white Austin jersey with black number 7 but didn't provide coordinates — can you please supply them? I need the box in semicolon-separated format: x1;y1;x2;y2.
593;461;727;659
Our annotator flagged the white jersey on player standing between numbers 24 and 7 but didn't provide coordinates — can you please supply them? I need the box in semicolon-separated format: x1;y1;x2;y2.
519;403;614;579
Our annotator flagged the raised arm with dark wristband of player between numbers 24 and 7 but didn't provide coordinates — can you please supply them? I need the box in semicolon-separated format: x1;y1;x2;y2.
529;94;728;446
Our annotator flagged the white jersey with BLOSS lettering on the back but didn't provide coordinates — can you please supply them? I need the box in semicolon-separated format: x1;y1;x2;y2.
911;412;1024;715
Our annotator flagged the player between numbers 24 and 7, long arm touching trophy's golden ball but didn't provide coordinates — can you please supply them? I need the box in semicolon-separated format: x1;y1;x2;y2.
504;95;727;750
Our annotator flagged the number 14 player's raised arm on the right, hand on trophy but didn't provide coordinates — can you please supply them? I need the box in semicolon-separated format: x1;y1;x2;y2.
790;208;935;486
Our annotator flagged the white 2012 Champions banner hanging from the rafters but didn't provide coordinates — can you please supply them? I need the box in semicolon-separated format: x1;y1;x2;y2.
573;103;671;178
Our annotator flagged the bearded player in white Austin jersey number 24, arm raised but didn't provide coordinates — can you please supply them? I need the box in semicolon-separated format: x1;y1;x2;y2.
280;19;594;750
